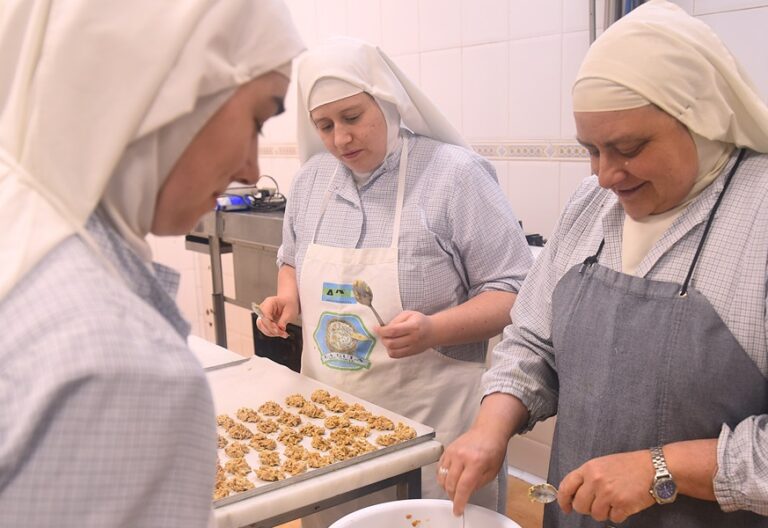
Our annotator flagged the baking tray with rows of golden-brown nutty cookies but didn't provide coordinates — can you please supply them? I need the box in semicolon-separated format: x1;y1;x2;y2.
208;357;435;507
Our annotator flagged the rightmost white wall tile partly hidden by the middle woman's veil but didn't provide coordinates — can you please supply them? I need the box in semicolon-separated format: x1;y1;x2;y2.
421;49;461;130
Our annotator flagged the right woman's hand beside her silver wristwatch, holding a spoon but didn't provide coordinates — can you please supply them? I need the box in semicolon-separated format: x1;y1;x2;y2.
557;450;655;523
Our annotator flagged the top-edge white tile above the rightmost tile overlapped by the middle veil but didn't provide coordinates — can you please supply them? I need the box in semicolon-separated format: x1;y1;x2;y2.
418;0;461;51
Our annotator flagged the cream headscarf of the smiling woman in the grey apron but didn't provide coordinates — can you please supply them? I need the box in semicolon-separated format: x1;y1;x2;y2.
573;0;768;153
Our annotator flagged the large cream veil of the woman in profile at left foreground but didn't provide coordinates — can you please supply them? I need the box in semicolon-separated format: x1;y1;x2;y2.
0;0;303;298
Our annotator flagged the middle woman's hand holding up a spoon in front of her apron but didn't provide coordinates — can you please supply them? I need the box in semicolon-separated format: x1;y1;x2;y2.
373;310;436;358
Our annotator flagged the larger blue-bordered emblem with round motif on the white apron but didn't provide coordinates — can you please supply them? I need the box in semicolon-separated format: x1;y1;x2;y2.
312;312;376;370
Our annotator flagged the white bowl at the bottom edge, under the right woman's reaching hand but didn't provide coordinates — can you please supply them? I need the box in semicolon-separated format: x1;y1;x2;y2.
330;499;520;528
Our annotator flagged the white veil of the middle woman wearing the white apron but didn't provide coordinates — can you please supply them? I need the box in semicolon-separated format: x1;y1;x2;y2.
297;37;469;163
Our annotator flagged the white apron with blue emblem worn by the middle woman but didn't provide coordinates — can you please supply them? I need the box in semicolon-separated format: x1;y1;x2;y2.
299;139;499;528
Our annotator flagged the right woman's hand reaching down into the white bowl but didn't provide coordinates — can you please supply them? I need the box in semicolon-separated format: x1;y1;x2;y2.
437;424;507;515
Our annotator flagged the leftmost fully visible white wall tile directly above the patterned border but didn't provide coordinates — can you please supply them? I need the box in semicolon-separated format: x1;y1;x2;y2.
461;44;509;141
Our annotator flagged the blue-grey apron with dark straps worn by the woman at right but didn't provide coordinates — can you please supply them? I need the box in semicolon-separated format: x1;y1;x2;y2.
544;151;768;528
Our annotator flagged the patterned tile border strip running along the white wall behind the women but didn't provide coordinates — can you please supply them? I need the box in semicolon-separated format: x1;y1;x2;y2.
259;141;589;161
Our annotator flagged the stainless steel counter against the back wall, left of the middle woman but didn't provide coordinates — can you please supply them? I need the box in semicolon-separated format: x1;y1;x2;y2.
186;211;283;348
